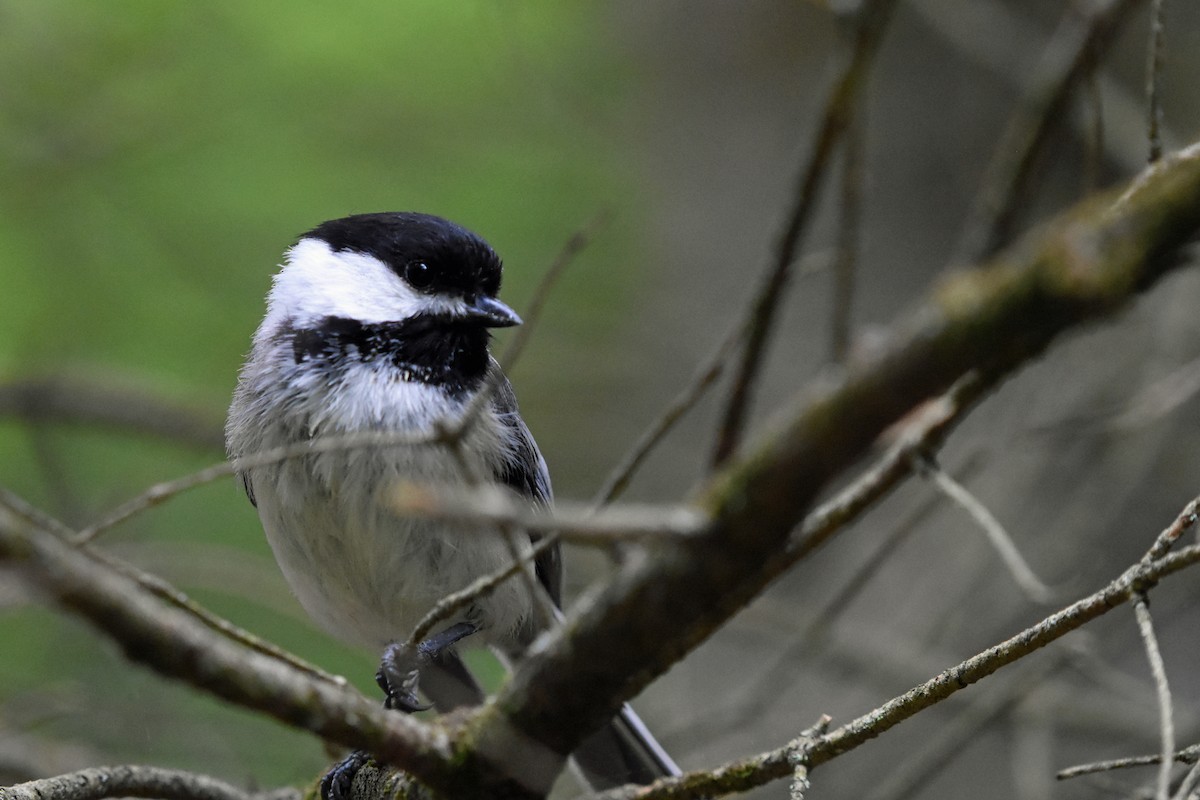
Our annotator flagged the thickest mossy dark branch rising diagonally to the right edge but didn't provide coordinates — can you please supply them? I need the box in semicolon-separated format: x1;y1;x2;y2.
475;140;1200;777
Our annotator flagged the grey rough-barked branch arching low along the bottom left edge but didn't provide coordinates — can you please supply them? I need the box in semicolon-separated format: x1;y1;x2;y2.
0;765;300;800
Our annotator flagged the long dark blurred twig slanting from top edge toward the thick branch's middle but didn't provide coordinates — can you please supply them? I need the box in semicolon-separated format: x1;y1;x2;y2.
712;0;895;465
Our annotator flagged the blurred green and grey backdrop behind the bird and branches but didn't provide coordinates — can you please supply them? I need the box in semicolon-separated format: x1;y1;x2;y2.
0;0;1200;799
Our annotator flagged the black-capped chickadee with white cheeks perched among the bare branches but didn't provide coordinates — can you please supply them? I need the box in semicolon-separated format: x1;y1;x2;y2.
226;212;678;798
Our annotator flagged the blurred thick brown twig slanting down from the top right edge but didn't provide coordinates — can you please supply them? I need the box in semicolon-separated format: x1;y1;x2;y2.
956;0;1141;263
